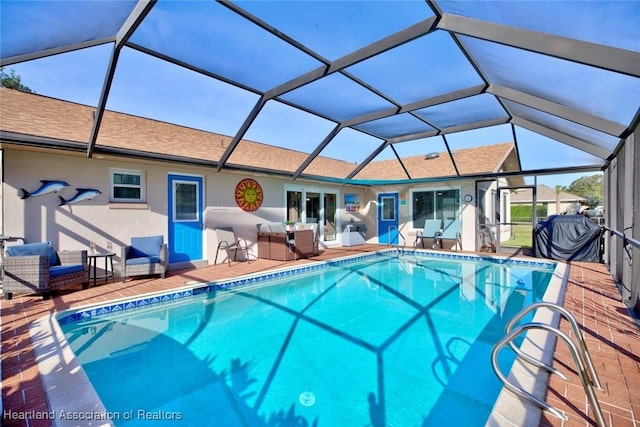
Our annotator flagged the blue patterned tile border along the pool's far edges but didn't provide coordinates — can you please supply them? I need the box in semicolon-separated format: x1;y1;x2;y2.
55;248;557;325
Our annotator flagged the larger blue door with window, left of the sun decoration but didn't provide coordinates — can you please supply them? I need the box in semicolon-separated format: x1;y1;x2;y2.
168;175;204;263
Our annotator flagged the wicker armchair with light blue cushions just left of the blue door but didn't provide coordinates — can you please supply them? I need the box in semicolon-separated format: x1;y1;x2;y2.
120;235;168;283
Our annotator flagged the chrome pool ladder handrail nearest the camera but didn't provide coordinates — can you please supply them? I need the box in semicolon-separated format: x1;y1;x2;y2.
491;322;606;427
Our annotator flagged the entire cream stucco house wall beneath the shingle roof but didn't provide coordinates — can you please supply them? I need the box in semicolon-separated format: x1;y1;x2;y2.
2;149;510;270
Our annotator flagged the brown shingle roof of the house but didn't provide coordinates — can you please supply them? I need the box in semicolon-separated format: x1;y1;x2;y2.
0;88;517;180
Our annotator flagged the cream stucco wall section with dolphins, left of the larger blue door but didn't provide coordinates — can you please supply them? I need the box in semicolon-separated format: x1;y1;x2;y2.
3;150;167;260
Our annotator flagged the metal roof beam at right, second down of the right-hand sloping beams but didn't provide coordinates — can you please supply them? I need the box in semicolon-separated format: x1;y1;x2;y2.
487;84;626;137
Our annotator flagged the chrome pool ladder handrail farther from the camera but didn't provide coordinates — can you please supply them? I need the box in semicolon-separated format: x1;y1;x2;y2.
505;301;602;390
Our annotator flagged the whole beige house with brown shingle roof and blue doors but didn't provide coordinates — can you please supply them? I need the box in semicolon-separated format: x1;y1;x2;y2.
0;88;518;269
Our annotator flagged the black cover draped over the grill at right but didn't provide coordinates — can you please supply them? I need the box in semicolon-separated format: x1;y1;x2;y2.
533;215;602;262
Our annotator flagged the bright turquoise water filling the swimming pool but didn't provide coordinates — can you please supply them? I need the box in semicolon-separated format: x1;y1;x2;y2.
61;253;554;427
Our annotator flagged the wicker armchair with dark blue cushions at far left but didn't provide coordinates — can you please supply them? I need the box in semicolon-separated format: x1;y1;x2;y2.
2;241;89;299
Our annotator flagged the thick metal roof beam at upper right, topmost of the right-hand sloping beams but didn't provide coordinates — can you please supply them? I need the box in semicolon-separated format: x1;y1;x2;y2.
438;13;640;77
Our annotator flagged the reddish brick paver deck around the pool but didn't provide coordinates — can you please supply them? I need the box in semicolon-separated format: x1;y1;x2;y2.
0;245;640;427
